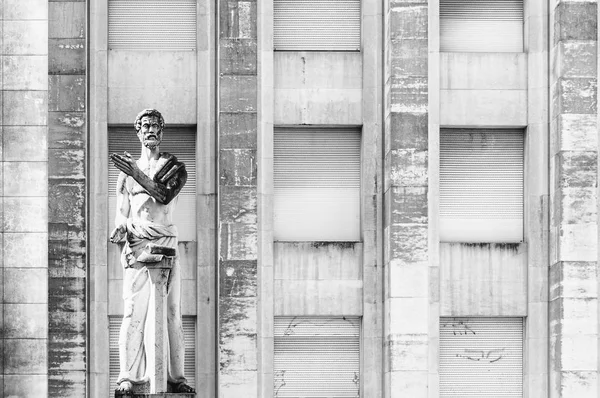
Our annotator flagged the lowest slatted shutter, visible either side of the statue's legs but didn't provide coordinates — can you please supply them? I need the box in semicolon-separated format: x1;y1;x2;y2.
108;316;196;388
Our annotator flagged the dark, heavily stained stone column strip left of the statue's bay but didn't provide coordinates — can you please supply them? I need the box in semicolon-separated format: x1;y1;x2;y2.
48;1;87;397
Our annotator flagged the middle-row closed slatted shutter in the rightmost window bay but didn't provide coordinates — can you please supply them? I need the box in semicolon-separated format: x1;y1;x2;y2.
440;129;524;242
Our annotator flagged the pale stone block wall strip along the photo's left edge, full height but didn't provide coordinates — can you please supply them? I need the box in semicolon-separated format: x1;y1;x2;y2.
0;0;51;397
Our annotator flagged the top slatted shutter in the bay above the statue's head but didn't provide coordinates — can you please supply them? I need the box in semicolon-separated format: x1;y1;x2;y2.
108;0;196;51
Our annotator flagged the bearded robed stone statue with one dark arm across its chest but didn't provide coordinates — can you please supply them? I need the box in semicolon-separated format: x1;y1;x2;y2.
110;109;194;395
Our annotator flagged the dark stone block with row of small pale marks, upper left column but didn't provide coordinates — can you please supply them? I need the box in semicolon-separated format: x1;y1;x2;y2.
48;39;86;75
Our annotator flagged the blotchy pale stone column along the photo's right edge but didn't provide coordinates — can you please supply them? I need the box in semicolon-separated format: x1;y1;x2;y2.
549;1;600;398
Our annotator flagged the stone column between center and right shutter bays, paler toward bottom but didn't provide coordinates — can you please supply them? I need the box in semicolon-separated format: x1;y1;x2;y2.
383;0;429;398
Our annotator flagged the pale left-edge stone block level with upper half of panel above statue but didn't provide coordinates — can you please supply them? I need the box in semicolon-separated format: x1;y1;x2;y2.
2;55;48;90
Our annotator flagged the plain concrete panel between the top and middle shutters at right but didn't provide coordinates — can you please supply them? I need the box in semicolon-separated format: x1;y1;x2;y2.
440;53;527;127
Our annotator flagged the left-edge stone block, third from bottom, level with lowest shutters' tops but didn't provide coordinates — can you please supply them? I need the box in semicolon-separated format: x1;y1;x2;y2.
3;303;48;339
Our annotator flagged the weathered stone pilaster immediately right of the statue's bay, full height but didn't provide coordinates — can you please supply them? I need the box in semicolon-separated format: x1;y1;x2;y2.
218;0;258;398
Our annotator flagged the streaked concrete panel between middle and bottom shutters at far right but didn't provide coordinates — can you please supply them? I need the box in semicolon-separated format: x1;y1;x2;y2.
440;243;527;316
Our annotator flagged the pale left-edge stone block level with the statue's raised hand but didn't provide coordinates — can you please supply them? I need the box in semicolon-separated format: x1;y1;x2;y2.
2;162;48;197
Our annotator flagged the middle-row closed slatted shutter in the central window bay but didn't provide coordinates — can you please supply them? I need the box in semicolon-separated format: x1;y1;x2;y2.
274;128;360;241
